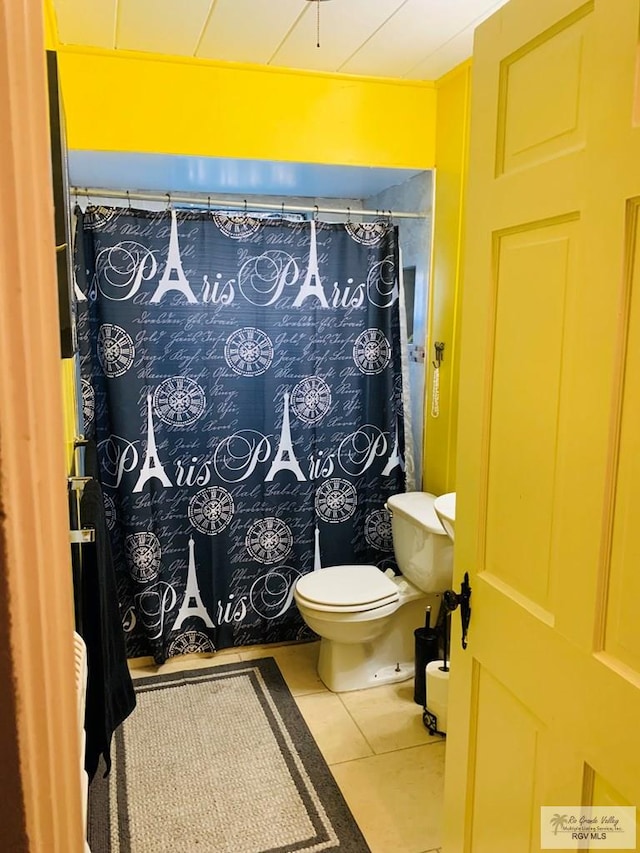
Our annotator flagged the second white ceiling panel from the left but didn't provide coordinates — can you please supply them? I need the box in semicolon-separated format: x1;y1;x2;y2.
116;0;211;56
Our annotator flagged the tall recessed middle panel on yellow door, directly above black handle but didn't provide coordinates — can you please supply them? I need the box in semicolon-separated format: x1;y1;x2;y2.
484;216;578;610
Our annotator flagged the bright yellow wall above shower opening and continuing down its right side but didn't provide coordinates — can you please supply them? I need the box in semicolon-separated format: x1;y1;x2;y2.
50;41;464;492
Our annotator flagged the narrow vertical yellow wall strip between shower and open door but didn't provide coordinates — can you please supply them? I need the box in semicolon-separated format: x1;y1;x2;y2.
423;61;471;494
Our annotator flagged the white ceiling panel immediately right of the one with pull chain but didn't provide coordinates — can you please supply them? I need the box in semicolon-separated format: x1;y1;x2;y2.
340;0;504;77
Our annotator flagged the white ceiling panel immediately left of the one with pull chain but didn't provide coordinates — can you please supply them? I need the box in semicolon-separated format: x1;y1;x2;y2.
196;0;308;64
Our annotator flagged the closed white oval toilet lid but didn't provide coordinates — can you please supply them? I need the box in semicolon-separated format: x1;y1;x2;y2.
296;566;399;608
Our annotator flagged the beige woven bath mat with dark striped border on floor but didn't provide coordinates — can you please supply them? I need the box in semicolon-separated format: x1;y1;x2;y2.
89;658;370;853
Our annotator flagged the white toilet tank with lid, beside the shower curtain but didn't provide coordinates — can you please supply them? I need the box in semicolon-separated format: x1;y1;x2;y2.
386;492;453;592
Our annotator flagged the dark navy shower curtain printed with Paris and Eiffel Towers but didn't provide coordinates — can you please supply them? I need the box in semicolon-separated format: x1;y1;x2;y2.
76;207;405;662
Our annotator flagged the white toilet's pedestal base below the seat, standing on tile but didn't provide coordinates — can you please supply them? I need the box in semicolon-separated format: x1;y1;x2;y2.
318;594;440;693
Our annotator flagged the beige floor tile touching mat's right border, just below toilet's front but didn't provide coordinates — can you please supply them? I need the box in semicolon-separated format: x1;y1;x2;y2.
296;691;373;764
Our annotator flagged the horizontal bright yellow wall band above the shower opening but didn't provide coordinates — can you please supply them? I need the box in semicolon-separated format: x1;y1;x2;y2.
58;47;436;169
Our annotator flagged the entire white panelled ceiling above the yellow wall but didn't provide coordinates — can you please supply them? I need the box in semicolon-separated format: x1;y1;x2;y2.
53;0;507;80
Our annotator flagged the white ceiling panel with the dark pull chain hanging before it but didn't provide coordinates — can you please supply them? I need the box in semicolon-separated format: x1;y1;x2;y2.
271;0;406;71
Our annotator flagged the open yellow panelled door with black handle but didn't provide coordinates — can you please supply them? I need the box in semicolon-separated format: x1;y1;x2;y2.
444;0;640;853
